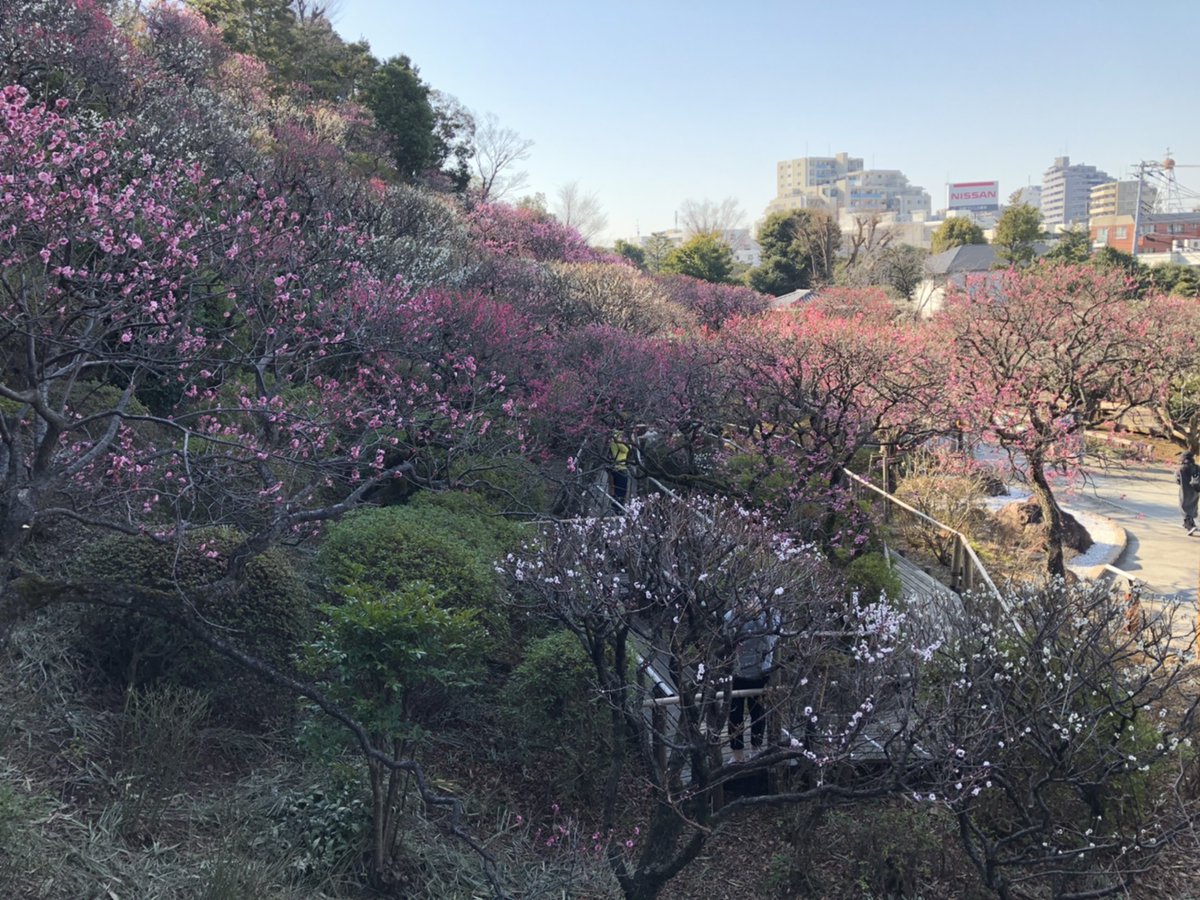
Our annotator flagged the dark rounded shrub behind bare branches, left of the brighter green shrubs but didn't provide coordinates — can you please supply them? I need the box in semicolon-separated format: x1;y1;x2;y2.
73;528;312;724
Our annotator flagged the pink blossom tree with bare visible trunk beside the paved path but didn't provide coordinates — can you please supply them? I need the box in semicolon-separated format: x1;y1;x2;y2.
930;265;1198;576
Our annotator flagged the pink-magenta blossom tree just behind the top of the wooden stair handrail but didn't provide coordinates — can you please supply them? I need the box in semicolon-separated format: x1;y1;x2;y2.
718;290;940;535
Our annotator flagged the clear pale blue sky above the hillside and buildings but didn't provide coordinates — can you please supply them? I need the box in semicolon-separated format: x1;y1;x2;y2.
334;0;1200;241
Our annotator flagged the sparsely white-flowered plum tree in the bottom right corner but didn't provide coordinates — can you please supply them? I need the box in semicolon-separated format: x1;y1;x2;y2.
912;580;1200;899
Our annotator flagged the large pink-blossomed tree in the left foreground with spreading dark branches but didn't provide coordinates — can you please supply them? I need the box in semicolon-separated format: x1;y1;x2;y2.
0;79;509;607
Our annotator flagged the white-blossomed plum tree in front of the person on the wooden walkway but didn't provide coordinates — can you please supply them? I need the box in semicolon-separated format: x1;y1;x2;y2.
500;496;928;898
